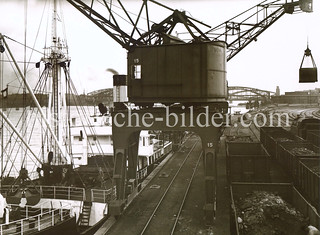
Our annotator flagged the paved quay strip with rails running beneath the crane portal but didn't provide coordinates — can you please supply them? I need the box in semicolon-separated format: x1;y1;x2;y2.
106;134;202;235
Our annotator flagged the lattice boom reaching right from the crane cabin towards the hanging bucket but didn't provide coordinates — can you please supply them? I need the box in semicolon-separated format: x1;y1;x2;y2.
206;0;312;61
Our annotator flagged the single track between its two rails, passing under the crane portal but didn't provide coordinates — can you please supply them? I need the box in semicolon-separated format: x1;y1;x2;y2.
140;137;202;235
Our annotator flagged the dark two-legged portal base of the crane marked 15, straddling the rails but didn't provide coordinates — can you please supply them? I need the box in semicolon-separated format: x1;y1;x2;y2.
109;104;227;218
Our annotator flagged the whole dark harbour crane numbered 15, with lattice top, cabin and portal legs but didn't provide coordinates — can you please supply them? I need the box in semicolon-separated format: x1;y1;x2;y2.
67;0;313;224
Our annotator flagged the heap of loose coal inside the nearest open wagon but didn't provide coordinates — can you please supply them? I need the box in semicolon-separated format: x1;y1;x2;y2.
235;191;306;235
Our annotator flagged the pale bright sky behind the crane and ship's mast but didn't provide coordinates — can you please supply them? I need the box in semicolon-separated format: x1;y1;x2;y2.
0;0;320;94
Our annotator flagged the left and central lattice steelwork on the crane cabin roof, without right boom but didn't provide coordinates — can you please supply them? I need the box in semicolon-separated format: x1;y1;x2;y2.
67;0;210;50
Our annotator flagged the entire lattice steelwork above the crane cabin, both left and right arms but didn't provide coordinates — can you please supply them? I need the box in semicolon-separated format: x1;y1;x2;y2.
67;0;312;61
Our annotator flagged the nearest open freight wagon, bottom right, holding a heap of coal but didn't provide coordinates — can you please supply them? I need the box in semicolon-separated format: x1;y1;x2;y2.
230;183;320;235
